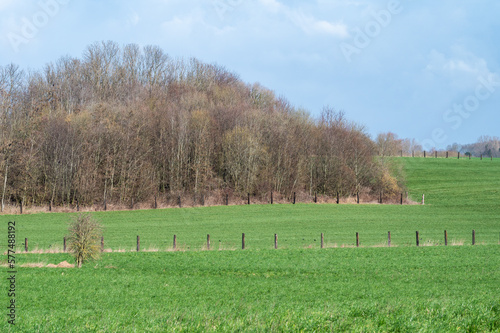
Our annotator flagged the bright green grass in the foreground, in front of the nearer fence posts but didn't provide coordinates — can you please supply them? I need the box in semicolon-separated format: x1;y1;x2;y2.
0;246;500;332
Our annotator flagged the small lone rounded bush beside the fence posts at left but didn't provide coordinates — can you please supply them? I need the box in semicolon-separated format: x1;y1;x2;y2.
67;214;102;268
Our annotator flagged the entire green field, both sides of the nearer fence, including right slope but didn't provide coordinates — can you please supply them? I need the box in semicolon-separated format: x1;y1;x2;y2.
0;158;500;332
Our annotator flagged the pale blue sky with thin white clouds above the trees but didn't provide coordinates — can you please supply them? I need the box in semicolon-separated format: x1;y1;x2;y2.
0;0;500;150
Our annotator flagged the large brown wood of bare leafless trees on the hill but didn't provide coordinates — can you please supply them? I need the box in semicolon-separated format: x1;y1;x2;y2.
0;42;402;206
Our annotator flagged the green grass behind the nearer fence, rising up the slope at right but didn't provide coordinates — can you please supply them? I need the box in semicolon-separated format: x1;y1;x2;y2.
0;158;500;251
